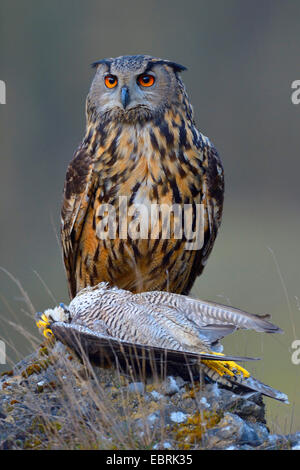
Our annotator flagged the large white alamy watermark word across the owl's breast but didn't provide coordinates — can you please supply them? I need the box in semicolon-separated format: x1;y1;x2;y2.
96;196;205;250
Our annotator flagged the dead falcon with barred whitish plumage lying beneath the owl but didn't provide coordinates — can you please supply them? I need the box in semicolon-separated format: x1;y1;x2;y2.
38;283;287;401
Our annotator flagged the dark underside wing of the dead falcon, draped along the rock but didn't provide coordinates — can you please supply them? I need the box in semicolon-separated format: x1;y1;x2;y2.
51;322;288;403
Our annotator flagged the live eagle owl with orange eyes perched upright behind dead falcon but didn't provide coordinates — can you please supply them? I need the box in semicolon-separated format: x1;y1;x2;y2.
61;55;224;298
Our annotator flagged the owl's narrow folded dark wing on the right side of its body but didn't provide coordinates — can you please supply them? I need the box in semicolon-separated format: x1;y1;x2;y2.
182;139;224;294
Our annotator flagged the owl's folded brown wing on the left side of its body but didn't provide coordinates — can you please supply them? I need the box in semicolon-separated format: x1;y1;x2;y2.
61;146;97;298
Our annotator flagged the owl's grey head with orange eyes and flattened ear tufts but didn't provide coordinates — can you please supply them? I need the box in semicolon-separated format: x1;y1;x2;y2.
87;55;186;122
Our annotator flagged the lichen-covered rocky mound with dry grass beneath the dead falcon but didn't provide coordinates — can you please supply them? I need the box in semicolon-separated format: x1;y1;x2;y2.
0;342;300;450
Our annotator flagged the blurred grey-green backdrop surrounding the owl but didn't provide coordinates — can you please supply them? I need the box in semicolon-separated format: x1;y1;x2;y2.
0;0;300;433
